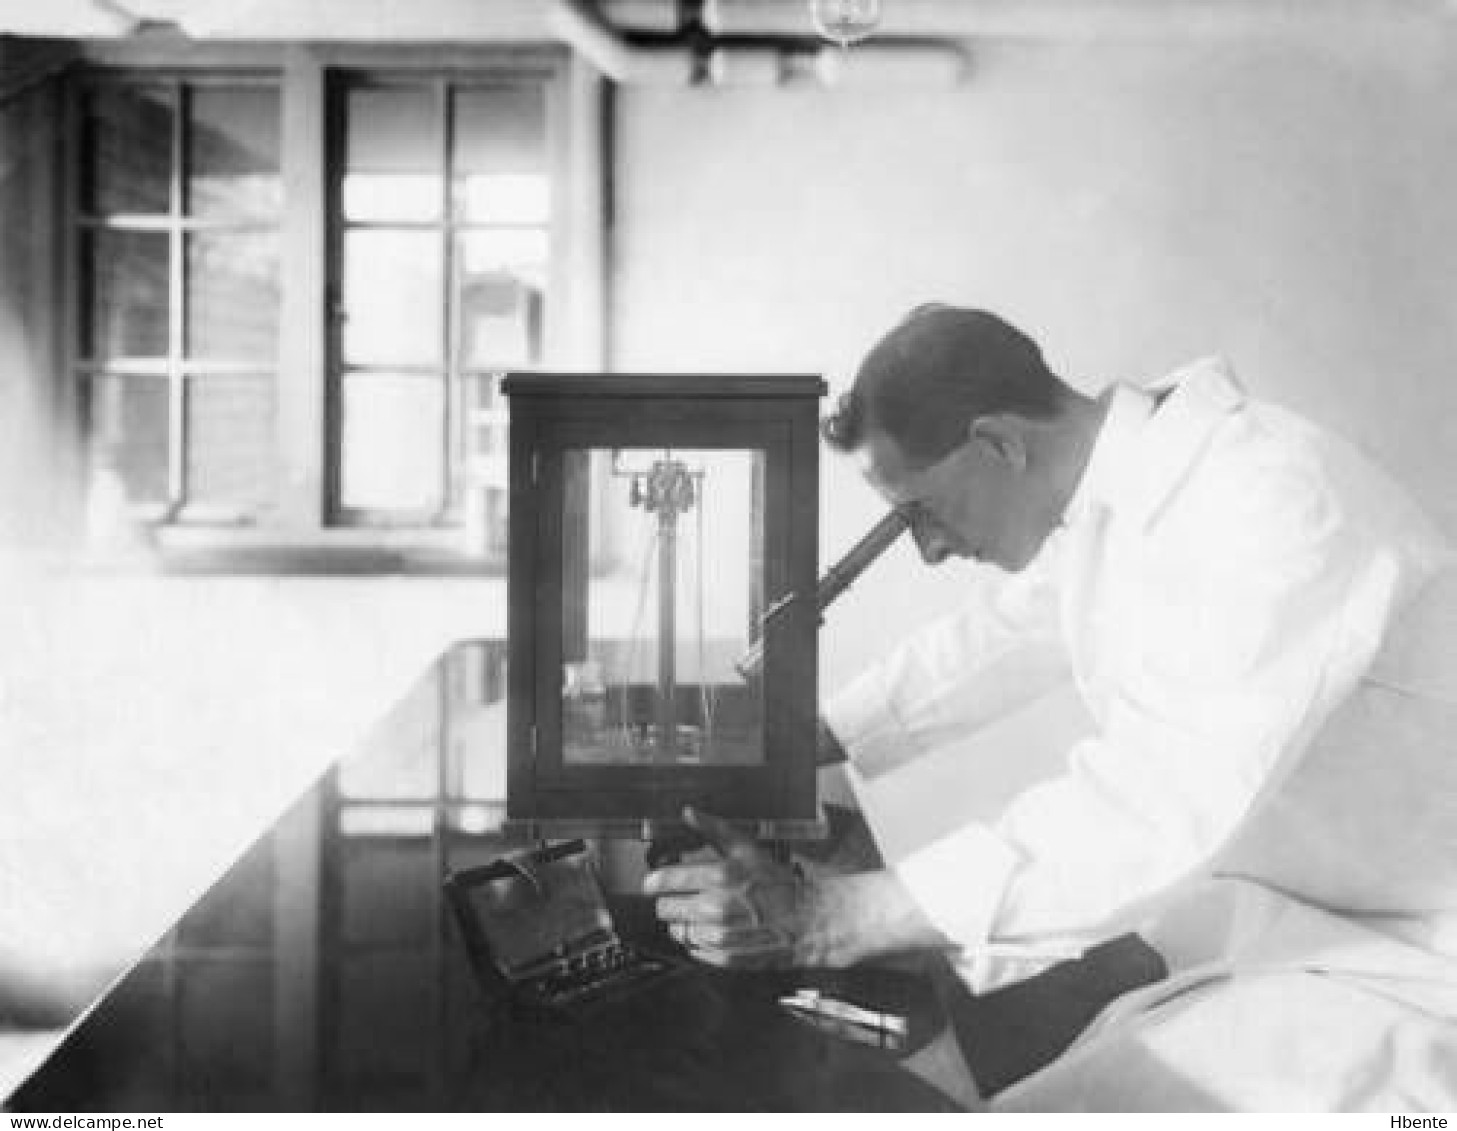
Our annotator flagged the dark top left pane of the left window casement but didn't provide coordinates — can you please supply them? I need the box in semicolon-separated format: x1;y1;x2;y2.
82;83;175;216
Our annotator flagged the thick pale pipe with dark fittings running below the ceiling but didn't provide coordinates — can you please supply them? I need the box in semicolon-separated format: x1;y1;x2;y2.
546;0;969;86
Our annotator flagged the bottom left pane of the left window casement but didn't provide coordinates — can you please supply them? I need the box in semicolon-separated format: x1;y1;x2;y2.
92;376;170;503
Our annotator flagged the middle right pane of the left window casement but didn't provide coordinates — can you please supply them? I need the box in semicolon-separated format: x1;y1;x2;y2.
186;232;278;366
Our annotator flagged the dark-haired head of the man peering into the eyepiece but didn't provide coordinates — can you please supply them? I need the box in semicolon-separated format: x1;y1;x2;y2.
825;305;1097;570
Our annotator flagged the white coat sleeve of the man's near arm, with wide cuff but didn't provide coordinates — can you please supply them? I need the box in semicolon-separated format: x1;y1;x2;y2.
898;457;1396;979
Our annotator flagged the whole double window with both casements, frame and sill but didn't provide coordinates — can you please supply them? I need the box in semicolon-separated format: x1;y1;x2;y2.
70;45;602;573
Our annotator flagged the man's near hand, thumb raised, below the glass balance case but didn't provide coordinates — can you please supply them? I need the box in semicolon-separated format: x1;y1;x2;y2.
643;809;947;968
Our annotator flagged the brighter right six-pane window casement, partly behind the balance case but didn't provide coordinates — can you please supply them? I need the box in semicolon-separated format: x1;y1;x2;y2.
331;77;552;554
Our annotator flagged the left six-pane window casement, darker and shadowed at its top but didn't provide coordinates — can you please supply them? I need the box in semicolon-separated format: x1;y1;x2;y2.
76;79;283;523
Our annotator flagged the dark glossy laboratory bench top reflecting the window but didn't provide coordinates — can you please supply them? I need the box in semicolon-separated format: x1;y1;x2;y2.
6;632;1163;1112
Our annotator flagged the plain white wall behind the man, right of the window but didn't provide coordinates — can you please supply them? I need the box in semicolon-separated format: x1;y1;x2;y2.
610;19;1457;686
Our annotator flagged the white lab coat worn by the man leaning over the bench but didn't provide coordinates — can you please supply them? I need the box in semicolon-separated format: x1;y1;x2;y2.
826;360;1457;1108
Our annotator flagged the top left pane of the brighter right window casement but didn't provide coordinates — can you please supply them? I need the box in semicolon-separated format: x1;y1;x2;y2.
344;87;443;220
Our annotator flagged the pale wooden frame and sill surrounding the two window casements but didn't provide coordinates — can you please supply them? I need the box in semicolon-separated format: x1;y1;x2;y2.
63;36;608;579
